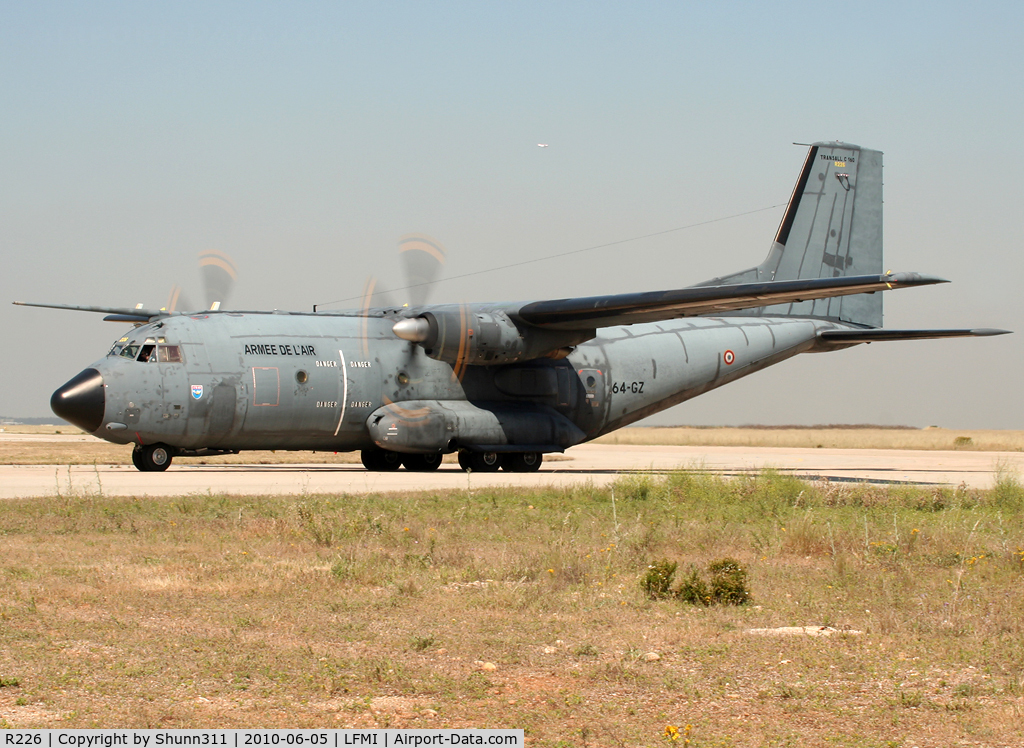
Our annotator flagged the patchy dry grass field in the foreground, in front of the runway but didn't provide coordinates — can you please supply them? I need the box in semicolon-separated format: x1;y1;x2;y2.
0;473;1024;746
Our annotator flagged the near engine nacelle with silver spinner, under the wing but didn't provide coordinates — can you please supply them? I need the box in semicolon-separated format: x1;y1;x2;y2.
392;307;594;365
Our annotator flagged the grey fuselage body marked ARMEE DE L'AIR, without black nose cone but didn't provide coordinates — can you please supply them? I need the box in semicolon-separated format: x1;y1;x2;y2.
75;313;843;451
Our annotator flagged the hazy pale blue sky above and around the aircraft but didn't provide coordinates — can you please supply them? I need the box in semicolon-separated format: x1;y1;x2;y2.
0;2;1024;428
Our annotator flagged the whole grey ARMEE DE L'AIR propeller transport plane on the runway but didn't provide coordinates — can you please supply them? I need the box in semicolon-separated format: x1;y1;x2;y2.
15;142;1006;471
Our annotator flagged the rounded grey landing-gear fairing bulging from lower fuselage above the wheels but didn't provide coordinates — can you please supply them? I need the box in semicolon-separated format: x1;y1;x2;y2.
367;400;587;454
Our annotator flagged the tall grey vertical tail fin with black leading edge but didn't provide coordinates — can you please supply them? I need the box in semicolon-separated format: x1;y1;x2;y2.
699;142;885;327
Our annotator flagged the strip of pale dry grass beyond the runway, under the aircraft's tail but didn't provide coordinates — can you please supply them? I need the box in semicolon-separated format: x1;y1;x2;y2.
596;426;1024;452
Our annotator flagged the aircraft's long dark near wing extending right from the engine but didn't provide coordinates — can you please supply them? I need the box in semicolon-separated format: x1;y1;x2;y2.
515;273;948;330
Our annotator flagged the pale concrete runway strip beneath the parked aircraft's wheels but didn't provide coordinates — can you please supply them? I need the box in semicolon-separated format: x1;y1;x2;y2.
0;444;1024;499
